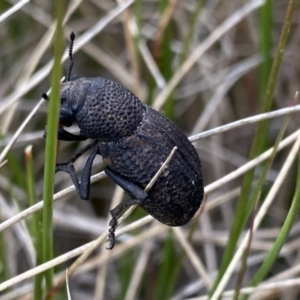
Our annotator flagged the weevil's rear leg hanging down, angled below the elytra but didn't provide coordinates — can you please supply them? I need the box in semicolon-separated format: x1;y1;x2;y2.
105;168;148;250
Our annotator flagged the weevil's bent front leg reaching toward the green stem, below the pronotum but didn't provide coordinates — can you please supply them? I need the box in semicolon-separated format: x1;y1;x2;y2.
55;146;98;200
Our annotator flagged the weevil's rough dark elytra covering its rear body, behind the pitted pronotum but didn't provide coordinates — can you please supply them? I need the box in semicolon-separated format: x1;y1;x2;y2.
99;107;203;226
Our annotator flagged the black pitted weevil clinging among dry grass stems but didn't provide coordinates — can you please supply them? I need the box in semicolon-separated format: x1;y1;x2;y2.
44;32;204;249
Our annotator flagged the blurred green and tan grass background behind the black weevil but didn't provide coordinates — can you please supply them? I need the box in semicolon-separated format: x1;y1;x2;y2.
0;0;300;300
